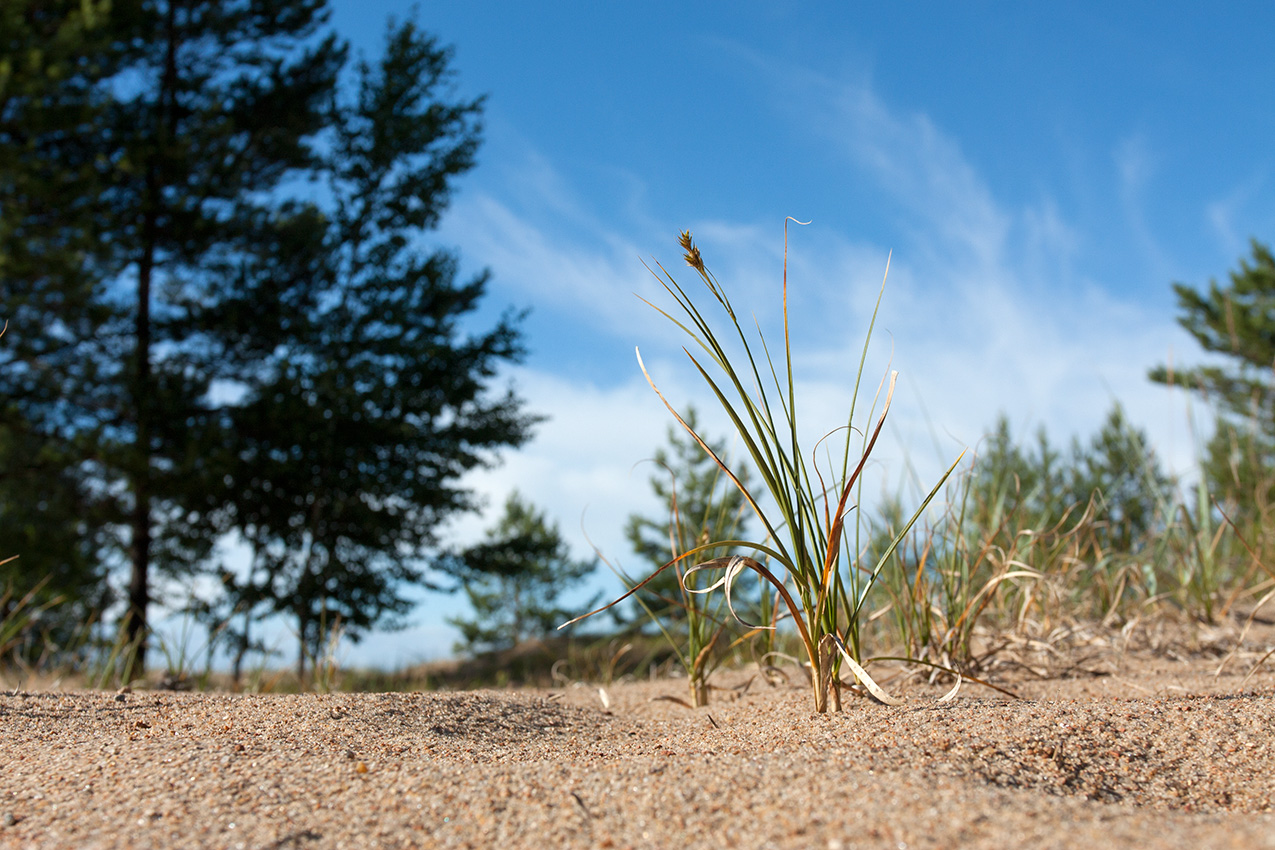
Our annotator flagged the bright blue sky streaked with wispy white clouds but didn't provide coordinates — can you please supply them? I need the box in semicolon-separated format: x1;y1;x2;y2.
269;0;1275;666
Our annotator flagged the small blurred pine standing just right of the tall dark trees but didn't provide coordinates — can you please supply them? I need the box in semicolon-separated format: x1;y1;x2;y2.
440;492;597;652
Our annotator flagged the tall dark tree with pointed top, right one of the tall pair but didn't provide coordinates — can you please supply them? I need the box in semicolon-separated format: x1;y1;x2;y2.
195;22;537;675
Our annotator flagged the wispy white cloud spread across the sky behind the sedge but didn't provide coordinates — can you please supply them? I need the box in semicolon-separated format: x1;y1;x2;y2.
341;48;1224;651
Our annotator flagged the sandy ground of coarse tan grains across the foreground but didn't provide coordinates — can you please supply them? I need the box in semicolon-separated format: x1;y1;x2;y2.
0;634;1275;850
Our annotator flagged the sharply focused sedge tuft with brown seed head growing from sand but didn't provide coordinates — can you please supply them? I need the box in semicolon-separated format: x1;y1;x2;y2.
564;225;960;714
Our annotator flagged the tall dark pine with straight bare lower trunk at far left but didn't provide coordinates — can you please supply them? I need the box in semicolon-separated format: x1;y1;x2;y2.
0;0;344;661
